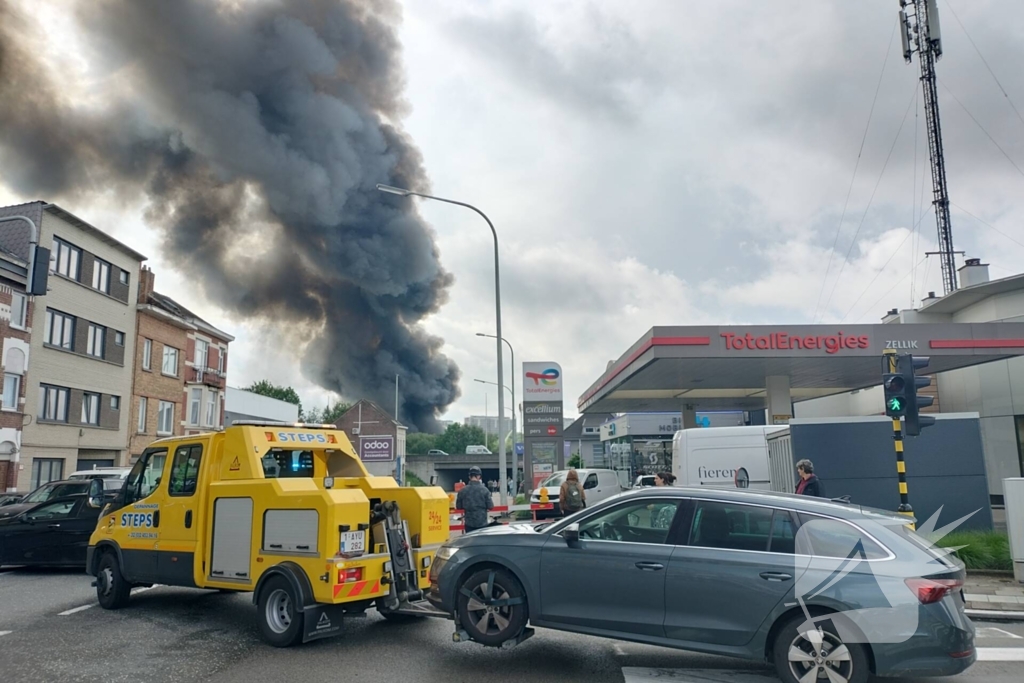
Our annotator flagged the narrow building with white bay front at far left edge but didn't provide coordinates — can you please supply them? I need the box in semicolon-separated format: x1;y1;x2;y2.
0;242;32;494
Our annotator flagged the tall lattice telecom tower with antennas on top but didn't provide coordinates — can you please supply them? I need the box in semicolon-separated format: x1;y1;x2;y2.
899;0;956;294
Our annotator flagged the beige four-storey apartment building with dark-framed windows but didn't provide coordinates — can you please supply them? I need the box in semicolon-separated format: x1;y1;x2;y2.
2;202;145;490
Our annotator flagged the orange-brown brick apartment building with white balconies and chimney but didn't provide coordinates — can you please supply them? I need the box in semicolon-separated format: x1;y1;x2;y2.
129;267;234;460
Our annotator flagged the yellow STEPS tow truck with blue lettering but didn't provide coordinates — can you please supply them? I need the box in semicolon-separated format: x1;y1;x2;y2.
79;422;449;647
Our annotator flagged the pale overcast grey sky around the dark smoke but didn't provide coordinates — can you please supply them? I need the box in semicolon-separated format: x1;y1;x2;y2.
0;0;1024;428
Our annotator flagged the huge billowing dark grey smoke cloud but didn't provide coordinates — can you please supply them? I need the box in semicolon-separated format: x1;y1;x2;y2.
0;0;459;429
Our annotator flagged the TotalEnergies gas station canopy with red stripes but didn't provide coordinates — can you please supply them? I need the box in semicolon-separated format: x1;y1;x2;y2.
578;323;1024;413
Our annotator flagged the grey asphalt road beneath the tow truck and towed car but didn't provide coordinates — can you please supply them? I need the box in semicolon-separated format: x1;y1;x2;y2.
0;569;1024;683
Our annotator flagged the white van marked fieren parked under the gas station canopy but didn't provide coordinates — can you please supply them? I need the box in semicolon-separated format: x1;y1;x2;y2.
672;425;785;490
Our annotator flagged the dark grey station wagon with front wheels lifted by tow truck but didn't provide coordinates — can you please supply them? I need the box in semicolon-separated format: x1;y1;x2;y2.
427;487;977;683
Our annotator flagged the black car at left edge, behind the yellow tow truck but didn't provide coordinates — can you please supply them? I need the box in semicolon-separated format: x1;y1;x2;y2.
0;489;108;568
